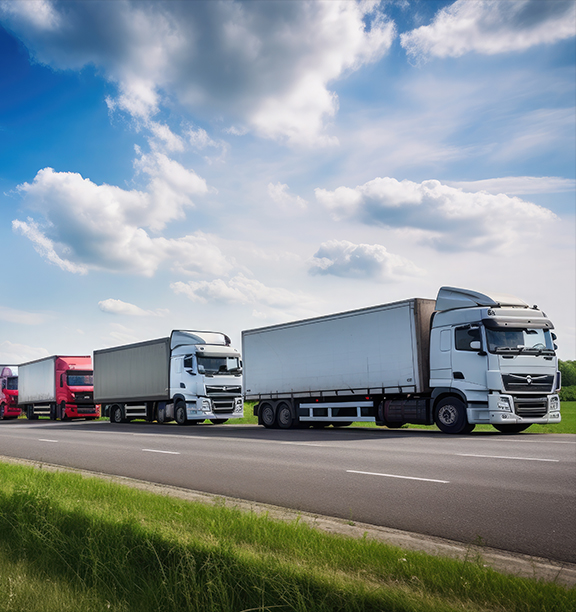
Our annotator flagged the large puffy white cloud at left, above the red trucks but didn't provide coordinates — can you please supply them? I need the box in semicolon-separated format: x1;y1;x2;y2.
12;164;230;276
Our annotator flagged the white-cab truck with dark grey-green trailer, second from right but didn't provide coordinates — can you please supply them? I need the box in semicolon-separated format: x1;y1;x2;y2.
94;330;244;425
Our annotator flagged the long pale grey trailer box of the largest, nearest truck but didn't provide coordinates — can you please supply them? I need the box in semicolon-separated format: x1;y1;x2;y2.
242;300;434;399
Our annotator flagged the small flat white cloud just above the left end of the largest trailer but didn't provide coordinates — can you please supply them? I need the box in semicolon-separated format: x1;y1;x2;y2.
170;274;302;308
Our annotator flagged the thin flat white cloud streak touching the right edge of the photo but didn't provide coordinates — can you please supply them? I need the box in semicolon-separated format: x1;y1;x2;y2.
446;176;576;195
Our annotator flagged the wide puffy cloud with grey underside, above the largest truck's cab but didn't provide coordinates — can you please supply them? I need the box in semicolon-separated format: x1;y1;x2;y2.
315;177;556;251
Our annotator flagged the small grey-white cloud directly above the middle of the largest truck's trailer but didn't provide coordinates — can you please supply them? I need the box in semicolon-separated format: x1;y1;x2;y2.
309;240;424;282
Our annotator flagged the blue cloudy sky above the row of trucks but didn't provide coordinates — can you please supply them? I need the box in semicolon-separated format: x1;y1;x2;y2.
0;0;576;363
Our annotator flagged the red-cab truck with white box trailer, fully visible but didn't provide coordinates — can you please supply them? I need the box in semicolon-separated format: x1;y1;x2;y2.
18;355;100;421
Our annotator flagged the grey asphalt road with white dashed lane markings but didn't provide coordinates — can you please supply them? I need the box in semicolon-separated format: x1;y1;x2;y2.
0;420;576;563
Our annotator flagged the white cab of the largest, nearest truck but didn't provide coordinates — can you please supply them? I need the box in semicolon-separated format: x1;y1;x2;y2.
430;287;561;433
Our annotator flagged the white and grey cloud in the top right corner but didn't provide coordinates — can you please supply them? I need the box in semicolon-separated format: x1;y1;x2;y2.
400;0;576;60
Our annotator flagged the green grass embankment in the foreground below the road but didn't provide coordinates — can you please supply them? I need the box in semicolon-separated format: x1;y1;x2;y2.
0;463;576;612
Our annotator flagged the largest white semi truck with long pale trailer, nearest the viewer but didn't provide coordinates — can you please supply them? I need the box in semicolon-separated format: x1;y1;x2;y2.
242;287;560;434
